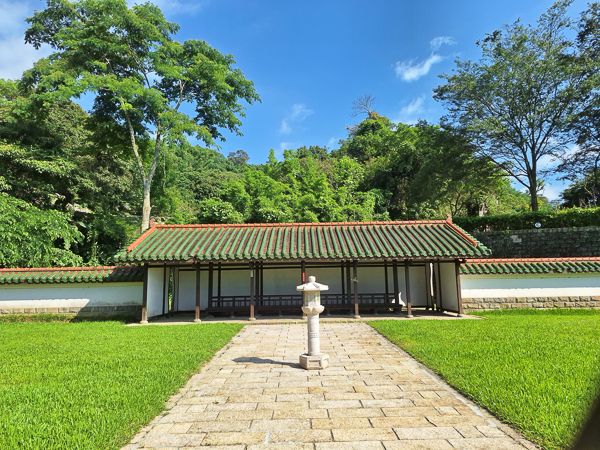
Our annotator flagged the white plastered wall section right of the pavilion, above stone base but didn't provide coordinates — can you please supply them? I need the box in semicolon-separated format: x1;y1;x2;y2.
460;273;600;298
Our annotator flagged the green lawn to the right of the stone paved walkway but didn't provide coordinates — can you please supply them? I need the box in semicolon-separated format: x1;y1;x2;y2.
370;310;600;449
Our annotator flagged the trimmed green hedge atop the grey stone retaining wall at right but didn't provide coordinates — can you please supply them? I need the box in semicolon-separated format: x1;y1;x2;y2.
452;207;600;232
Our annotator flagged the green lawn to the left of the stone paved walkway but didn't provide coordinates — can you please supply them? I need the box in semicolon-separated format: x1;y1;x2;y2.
0;322;242;450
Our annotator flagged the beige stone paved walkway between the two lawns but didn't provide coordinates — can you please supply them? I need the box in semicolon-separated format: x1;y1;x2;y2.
124;323;536;450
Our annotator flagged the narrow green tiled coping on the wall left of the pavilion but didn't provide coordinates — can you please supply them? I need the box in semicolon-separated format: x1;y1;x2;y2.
0;266;143;284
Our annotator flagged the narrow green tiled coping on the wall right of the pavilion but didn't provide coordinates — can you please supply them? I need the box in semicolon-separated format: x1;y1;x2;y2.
460;258;600;275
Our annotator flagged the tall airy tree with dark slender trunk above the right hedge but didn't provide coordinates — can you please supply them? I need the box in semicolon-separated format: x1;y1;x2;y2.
434;0;586;211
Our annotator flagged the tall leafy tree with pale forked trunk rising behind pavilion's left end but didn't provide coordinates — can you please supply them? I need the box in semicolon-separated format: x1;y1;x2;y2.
23;0;260;231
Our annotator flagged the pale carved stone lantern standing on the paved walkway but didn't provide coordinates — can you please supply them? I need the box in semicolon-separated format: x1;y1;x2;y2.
296;277;329;370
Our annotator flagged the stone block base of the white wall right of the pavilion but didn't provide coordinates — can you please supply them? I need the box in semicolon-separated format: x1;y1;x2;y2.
463;296;600;312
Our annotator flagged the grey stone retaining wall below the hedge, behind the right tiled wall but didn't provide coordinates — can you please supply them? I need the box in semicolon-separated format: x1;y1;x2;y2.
471;227;600;258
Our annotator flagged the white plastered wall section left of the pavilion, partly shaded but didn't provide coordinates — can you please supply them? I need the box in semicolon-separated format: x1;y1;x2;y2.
0;282;143;310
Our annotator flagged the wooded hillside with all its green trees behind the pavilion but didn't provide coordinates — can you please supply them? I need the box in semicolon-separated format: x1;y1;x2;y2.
0;0;600;267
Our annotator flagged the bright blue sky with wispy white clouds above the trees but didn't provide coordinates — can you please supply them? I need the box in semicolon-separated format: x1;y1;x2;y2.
0;0;586;198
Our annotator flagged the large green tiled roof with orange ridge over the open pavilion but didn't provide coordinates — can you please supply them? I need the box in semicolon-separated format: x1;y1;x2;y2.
117;220;490;262
